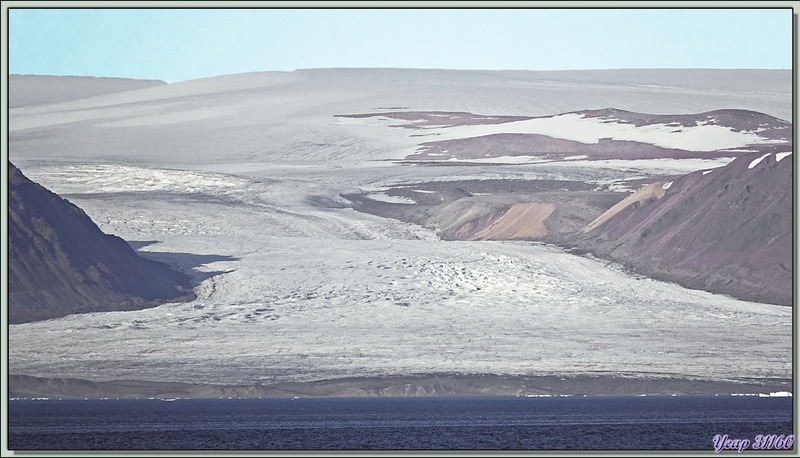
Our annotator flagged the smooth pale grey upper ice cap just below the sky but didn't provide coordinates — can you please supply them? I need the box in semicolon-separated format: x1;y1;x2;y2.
9;70;792;168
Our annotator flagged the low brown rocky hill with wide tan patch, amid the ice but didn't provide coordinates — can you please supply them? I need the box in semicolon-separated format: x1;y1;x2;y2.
342;180;625;240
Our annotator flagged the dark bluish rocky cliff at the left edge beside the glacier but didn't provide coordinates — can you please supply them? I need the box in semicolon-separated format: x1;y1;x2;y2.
8;163;194;323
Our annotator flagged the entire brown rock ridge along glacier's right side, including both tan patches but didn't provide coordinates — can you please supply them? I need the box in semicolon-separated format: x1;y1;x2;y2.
344;151;793;305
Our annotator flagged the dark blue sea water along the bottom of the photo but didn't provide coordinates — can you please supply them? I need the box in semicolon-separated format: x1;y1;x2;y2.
8;396;794;450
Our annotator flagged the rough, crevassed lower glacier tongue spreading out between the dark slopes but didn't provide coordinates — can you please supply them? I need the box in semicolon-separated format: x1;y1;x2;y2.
9;166;792;384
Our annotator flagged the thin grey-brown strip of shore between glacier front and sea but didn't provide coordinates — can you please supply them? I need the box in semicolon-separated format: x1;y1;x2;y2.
8;373;793;400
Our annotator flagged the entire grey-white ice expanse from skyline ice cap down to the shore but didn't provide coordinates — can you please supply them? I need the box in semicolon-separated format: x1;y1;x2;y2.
9;71;792;385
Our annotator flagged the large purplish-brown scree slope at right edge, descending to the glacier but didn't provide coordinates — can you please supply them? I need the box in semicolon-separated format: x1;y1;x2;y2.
579;153;793;305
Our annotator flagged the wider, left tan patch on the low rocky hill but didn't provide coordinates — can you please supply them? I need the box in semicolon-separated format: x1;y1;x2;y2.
470;203;555;240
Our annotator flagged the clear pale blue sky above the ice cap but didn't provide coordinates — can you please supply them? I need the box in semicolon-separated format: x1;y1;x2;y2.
9;6;792;81
